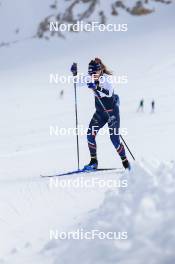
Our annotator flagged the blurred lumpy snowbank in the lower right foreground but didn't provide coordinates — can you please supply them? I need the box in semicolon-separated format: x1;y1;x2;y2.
40;162;175;264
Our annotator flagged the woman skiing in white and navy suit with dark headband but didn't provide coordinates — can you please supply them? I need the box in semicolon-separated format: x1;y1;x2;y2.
71;58;131;170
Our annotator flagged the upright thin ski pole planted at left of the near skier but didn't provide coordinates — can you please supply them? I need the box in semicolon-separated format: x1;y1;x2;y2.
73;63;80;170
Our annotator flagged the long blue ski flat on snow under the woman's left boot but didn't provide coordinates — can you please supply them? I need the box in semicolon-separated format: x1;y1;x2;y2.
40;168;123;178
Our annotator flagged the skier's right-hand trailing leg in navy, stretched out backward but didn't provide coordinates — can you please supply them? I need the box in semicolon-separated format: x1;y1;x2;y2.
108;106;130;169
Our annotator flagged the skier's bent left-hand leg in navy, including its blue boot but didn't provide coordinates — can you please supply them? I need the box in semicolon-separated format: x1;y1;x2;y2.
85;112;107;167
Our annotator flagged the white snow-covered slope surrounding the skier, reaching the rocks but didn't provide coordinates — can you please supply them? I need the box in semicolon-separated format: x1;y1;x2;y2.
0;1;175;264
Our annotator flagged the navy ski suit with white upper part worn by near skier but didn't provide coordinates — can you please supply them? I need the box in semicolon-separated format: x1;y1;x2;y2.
87;74;126;159
